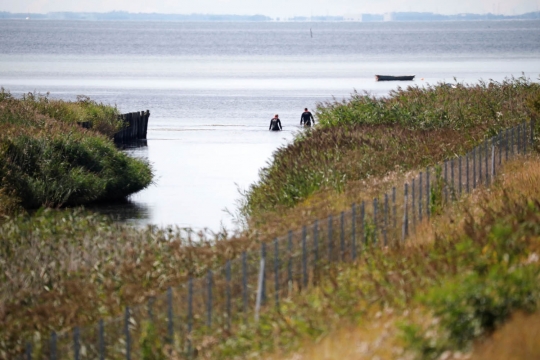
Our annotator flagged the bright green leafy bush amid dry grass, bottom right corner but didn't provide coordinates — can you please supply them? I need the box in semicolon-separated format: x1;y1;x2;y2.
402;264;540;359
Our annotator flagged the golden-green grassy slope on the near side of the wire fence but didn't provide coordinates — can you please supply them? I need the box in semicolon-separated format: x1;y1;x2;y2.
201;155;540;360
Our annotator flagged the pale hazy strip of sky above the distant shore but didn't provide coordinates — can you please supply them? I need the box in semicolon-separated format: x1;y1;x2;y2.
0;0;540;17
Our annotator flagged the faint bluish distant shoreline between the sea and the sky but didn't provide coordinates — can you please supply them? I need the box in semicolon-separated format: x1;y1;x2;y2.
0;10;540;22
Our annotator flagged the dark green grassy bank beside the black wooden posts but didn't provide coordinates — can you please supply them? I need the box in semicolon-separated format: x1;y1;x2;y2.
0;89;152;214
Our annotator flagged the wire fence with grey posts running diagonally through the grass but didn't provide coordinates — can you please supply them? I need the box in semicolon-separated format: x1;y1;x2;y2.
21;121;534;360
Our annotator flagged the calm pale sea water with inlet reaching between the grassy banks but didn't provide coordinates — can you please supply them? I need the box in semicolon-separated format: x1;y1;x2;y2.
0;21;540;230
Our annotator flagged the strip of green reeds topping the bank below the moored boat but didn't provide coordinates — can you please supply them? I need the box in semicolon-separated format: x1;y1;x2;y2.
317;77;540;131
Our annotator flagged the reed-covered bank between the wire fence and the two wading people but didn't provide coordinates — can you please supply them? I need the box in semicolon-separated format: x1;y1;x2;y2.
241;78;540;233
